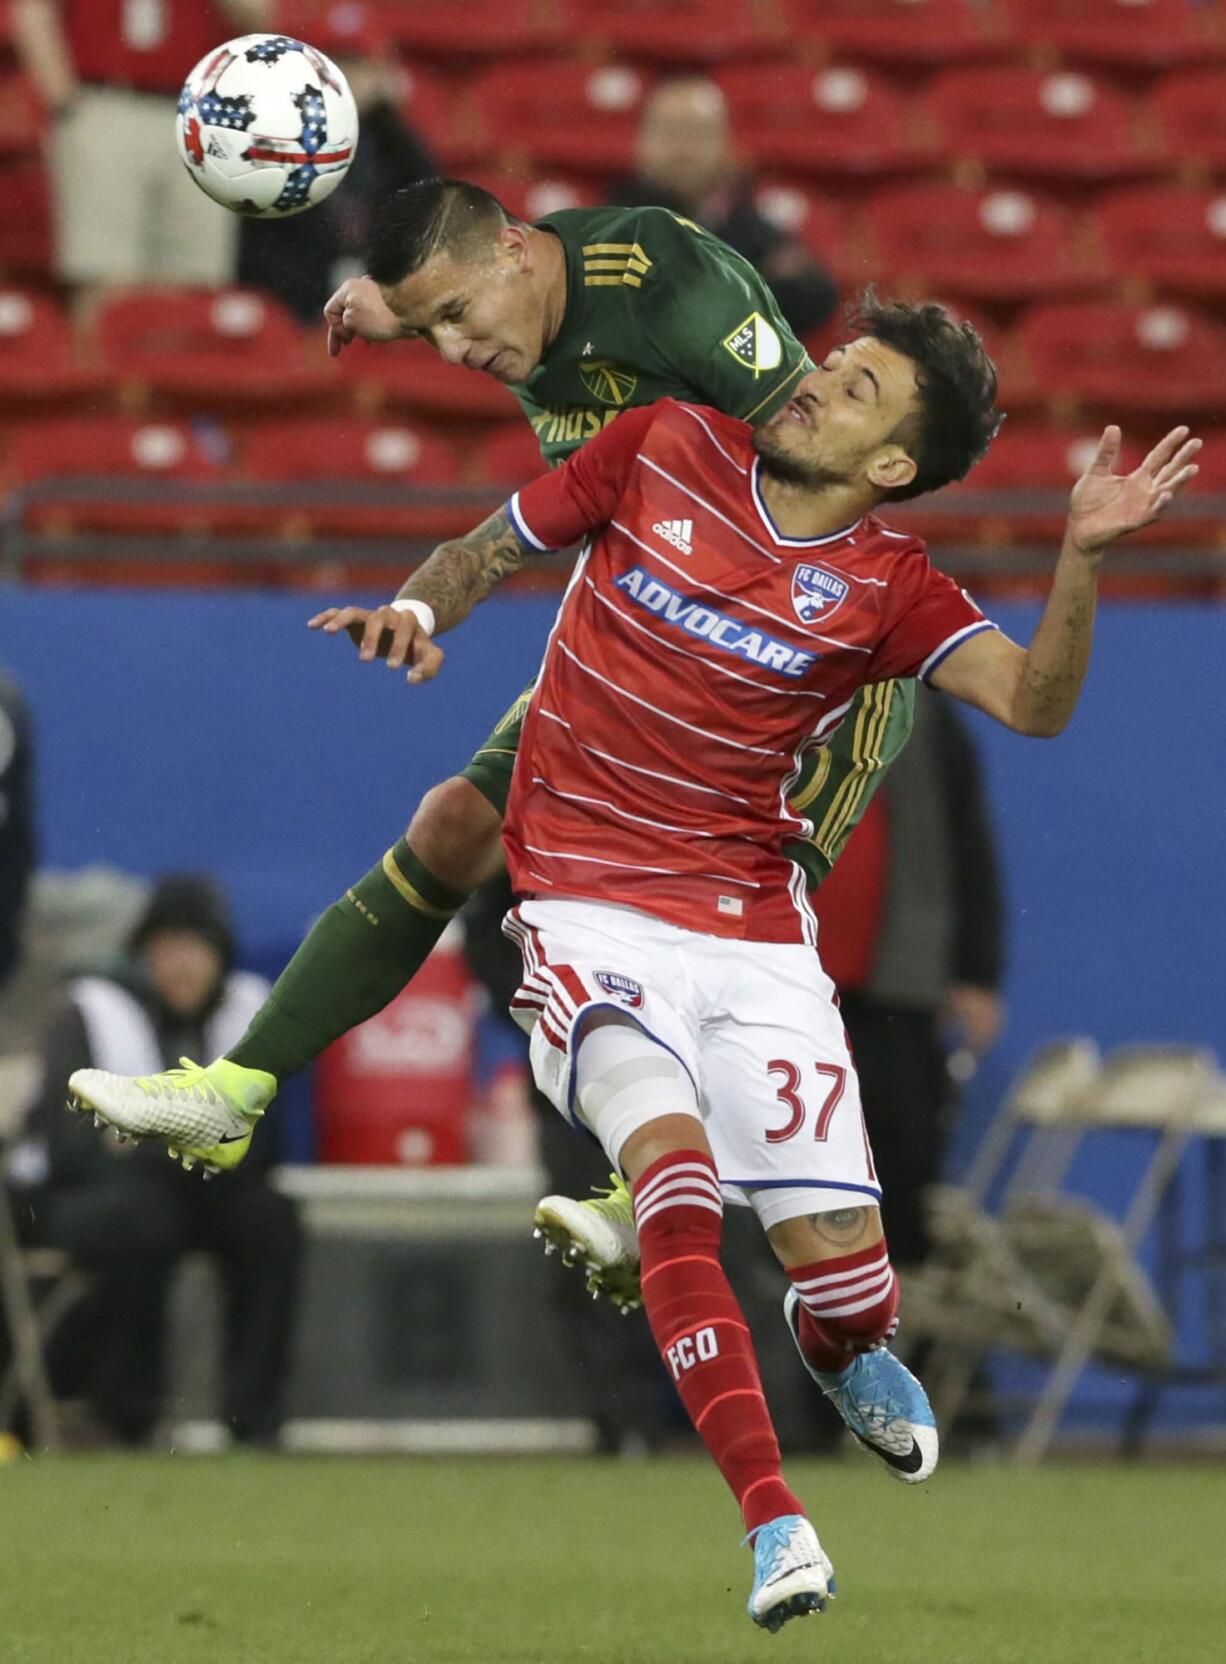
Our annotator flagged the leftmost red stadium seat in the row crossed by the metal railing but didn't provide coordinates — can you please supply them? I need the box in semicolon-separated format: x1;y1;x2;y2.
12;416;221;536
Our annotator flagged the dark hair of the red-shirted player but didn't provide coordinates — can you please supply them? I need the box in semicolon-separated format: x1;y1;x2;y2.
850;288;1005;503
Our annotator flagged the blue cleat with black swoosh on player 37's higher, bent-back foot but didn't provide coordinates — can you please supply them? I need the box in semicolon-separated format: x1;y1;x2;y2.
784;1288;940;1484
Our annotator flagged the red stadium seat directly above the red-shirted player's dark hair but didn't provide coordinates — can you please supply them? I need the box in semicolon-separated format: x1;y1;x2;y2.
863;185;1098;301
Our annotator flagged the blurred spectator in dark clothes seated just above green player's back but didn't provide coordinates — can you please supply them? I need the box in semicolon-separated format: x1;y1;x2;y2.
609;75;838;336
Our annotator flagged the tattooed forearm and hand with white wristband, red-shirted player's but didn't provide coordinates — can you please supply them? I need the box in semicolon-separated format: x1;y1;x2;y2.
308;508;526;682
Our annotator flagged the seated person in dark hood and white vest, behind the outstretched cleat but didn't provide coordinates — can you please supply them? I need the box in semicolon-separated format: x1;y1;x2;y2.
12;874;301;1444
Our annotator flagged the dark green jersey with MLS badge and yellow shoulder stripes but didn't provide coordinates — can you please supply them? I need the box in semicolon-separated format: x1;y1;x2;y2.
511;208;813;463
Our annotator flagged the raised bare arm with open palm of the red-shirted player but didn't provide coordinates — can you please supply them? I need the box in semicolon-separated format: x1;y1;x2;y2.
932;428;1201;739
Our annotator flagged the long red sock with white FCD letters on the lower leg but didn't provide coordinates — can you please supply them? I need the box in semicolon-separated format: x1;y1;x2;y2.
634;1150;803;1531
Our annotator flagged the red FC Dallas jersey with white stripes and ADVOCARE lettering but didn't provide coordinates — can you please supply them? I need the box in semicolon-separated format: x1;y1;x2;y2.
504;399;995;943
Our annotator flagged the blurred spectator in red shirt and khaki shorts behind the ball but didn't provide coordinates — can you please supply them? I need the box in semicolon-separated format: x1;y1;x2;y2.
12;0;273;298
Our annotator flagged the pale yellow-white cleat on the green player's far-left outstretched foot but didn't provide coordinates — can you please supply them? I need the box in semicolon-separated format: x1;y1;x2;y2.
68;1058;276;1176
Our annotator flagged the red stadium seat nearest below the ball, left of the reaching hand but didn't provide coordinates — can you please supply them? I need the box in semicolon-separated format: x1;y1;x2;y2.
95;288;338;409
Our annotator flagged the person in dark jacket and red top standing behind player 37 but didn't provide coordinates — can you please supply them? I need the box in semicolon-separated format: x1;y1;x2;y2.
813;687;1005;1271
